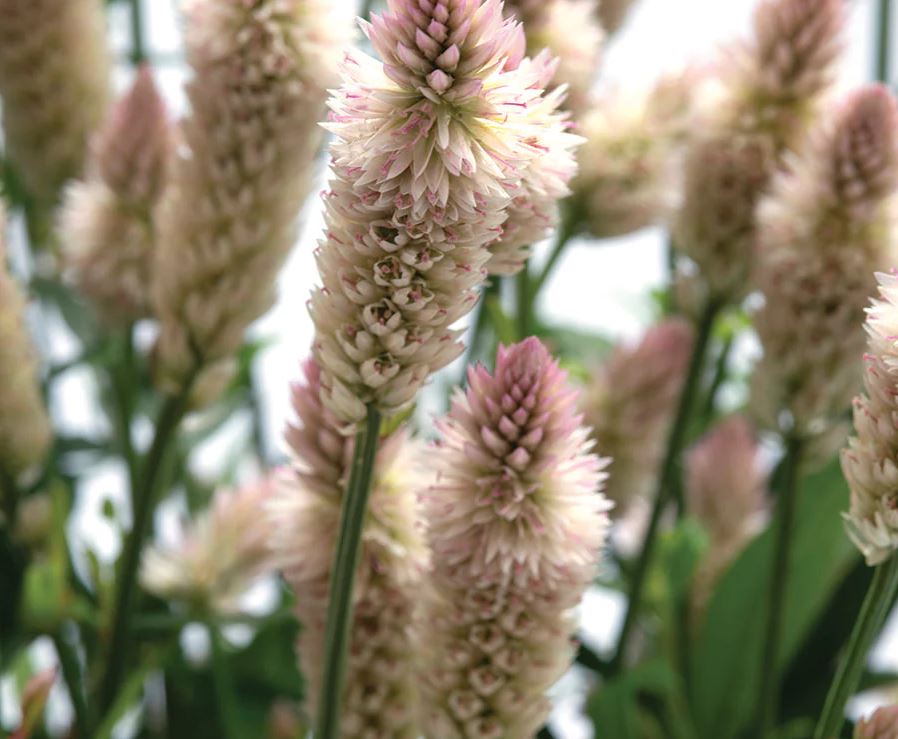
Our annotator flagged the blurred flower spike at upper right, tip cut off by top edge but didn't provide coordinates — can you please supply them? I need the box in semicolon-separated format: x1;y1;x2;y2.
673;0;845;300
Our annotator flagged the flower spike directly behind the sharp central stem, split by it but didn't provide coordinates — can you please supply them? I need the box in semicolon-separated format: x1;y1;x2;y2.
269;360;427;739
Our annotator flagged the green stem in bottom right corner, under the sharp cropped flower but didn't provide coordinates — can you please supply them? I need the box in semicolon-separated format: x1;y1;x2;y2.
814;554;898;739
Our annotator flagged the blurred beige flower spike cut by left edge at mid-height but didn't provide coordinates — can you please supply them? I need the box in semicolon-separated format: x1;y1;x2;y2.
0;206;51;478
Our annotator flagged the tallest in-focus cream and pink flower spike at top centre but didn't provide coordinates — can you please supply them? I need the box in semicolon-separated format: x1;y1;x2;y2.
311;0;576;425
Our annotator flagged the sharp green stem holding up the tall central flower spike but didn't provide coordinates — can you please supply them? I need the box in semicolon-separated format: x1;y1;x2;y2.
315;405;380;739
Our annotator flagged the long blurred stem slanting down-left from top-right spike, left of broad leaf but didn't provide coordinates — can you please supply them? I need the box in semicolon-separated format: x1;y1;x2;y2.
611;301;720;674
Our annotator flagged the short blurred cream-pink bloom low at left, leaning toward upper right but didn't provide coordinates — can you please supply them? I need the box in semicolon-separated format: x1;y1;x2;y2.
140;478;274;614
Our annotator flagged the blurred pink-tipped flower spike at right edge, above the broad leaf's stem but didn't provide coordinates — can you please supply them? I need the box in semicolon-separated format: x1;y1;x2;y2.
752;85;898;446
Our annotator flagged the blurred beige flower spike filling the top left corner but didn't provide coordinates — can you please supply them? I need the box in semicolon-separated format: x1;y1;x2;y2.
0;0;110;204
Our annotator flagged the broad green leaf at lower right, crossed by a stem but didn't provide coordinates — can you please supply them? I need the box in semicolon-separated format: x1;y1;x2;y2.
692;462;858;739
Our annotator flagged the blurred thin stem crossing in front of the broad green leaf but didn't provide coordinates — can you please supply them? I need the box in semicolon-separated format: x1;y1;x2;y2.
758;436;802;738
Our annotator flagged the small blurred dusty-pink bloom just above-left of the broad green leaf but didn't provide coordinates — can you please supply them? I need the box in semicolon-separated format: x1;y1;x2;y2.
686;416;767;610
